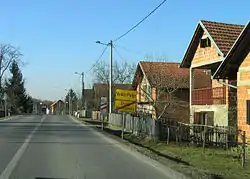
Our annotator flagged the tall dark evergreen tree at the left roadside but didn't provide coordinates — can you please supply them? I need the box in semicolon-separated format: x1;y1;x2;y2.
5;61;32;113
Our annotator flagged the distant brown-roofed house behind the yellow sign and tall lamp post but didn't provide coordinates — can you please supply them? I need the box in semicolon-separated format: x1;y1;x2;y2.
93;83;132;111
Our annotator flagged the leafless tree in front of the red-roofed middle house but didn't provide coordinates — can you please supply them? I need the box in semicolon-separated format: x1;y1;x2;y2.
141;62;189;120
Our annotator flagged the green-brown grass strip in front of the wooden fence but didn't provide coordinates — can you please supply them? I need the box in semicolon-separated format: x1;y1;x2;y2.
126;135;250;179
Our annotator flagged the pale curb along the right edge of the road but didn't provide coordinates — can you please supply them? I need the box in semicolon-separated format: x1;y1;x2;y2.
70;116;190;179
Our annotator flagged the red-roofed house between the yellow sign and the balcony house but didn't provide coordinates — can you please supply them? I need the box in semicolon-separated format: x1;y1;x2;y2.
132;61;207;122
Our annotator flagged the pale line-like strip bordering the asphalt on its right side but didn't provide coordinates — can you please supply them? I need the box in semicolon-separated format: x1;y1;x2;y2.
69;116;189;179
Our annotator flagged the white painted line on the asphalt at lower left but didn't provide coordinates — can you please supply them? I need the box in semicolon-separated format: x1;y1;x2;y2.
0;116;46;179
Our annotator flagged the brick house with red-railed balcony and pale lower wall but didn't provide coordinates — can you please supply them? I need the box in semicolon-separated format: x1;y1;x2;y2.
180;20;244;126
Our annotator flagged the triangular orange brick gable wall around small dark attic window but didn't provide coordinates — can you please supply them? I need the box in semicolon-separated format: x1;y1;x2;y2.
191;32;222;67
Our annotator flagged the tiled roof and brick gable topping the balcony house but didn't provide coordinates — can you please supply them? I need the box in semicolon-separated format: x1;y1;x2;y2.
180;20;244;68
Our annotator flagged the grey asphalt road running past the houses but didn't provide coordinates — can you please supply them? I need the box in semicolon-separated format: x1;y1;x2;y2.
0;116;171;179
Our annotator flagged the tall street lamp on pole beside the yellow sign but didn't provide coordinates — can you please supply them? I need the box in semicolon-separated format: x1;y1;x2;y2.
96;40;113;119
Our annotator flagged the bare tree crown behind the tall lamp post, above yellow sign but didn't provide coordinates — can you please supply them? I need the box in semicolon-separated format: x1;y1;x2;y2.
93;61;136;84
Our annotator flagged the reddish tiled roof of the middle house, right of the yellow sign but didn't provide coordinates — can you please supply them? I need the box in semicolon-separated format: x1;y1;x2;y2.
140;62;210;88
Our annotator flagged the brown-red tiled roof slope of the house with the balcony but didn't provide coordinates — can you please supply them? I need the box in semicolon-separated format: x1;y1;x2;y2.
201;20;244;55
